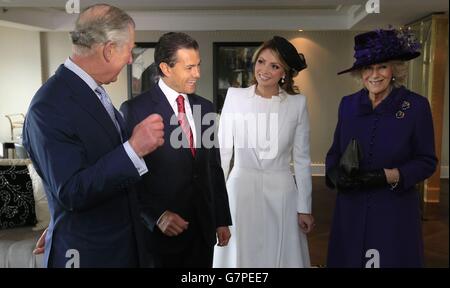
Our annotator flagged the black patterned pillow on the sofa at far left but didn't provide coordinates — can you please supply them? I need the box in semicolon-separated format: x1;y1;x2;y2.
0;165;36;229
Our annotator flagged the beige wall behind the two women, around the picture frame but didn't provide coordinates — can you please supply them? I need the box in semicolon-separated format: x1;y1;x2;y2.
136;31;359;163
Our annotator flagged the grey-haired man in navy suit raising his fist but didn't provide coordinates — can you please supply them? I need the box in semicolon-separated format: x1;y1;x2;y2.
23;4;164;267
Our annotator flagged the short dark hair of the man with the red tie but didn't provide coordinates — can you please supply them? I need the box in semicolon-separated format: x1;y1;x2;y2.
155;32;198;77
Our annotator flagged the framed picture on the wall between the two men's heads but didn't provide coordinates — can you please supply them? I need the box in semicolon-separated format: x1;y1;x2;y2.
127;42;159;99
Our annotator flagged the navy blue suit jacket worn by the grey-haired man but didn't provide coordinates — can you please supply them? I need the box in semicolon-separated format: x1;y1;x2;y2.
23;65;141;267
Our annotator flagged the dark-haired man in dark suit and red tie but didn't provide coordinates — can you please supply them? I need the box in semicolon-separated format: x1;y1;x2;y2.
121;32;231;267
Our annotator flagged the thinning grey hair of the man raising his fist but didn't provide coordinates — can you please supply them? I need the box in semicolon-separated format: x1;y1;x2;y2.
70;4;135;55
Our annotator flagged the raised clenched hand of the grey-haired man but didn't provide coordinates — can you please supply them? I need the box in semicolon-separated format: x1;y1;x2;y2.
128;114;164;157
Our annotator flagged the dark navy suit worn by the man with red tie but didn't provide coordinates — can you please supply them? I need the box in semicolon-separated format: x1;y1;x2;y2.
121;84;231;266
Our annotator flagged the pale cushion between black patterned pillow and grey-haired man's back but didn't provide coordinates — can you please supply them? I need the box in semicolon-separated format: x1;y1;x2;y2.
27;163;50;231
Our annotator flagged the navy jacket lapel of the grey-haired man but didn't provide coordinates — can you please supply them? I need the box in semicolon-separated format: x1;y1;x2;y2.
55;65;120;143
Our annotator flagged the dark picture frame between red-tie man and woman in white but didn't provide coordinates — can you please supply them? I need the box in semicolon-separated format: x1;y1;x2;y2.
213;42;262;113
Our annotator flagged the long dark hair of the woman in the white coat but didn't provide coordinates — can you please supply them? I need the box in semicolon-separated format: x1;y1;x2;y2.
252;39;300;95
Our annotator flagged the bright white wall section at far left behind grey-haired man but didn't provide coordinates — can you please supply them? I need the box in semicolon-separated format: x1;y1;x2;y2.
0;27;42;141
